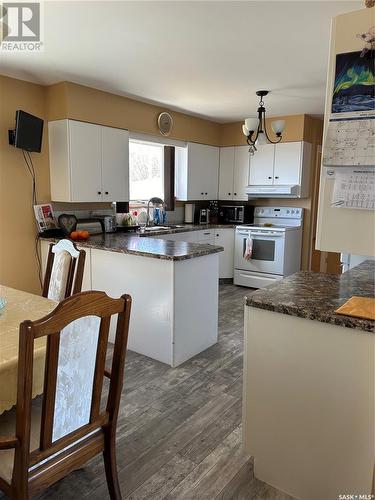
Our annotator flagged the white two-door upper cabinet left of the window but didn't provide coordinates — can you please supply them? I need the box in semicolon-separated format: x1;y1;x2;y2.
48;120;129;202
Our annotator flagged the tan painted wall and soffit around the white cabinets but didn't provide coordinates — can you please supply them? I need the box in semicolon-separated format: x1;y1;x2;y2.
0;75;321;292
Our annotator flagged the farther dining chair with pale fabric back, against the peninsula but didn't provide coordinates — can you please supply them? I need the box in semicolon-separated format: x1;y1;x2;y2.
42;240;86;302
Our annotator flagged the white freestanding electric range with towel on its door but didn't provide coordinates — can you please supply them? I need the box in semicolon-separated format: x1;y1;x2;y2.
233;207;303;288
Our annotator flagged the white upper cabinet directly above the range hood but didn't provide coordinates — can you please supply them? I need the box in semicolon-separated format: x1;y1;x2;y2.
249;142;311;198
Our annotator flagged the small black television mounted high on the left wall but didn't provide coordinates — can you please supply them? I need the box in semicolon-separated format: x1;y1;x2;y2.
14;109;44;153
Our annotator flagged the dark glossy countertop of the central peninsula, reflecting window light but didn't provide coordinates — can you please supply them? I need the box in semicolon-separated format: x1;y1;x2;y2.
40;233;224;261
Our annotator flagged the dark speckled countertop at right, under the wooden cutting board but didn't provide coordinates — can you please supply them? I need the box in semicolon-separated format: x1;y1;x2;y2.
246;260;375;333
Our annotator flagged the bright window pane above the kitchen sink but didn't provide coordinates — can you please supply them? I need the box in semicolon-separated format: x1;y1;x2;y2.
129;141;164;200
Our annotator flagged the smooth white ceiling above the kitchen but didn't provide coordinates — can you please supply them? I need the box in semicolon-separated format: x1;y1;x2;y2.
0;0;362;122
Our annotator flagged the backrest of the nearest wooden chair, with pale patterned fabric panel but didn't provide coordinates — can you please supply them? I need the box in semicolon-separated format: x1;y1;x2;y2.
13;291;131;482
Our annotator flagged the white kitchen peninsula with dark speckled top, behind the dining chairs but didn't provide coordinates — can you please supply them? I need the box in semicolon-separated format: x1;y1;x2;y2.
41;233;223;367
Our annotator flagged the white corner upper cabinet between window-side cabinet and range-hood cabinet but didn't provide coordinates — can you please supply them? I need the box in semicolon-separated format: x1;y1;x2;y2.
219;146;250;201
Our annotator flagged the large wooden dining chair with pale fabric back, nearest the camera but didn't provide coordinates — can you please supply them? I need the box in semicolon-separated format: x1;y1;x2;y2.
0;291;131;500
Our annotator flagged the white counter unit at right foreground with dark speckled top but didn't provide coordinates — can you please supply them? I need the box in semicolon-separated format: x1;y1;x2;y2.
243;261;375;500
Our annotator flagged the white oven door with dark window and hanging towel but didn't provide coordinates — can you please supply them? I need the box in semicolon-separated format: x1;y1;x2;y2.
234;229;285;276
